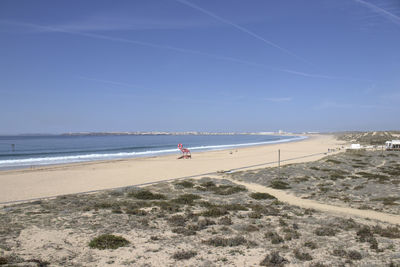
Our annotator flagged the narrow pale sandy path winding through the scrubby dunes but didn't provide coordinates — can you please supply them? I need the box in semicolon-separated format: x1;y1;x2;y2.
225;177;400;224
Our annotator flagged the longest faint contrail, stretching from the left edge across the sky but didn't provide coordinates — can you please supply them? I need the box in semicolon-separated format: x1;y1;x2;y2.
0;21;347;79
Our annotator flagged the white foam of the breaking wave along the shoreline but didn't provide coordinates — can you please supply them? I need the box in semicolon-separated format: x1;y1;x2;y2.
0;136;307;168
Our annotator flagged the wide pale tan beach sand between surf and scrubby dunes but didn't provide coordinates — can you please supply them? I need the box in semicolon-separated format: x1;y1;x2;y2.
0;135;343;203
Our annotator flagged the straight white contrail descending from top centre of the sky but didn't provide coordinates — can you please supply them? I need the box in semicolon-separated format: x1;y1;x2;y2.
176;0;310;64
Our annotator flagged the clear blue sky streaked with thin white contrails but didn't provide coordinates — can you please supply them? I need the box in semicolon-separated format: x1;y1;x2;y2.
0;0;400;134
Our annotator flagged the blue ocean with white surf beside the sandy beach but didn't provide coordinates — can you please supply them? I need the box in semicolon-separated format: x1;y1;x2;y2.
0;134;305;170
